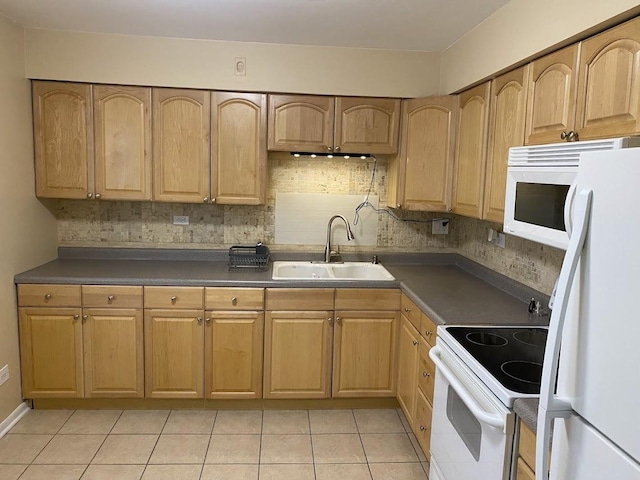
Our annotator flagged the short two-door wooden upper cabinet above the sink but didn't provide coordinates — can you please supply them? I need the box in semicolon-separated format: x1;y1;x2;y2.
268;95;400;154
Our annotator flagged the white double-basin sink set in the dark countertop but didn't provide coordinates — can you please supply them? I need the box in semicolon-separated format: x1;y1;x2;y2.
272;262;395;281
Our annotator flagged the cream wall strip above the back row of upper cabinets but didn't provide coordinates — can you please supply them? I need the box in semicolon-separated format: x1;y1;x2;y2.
25;28;440;97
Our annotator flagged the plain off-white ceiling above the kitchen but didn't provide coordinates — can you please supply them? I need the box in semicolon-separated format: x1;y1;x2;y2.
0;0;508;52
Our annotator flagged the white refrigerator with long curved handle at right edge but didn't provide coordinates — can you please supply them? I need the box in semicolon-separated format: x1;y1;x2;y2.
536;148;640;480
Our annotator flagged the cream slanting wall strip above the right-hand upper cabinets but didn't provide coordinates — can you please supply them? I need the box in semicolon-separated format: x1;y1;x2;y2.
440;0;640;93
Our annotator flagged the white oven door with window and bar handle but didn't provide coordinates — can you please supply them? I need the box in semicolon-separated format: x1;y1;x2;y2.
429;339;515;480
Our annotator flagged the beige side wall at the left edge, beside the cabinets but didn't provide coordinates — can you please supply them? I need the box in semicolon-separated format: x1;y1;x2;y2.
0;15;57;421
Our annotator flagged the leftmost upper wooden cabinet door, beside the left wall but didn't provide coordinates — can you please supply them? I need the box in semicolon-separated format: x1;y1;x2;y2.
33;82;94;198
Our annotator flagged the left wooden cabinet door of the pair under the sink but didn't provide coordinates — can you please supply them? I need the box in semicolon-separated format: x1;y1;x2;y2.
264;311;333;398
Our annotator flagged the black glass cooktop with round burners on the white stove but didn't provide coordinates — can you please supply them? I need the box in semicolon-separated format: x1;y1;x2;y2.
447;327;547;394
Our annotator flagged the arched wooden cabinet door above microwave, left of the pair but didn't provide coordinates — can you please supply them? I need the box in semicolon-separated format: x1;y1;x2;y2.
525;44;579;145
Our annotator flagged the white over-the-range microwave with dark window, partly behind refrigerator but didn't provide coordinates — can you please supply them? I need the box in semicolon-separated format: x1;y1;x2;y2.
504;137;640;250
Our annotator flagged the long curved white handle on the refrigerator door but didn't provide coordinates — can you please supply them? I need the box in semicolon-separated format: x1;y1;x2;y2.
536;190;593;480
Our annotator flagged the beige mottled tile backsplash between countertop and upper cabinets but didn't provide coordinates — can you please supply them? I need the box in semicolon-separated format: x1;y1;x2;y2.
56;154;564;294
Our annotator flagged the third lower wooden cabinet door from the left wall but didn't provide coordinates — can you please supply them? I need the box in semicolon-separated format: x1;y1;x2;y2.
144;309;204;398
